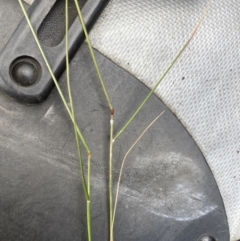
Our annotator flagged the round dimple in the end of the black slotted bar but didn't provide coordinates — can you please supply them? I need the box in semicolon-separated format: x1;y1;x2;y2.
10;56;42;87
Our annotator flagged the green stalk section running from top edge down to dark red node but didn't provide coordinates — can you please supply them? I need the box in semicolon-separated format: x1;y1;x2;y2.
74;0;113;110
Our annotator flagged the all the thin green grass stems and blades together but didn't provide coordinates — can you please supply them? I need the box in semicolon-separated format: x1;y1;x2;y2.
18;0;212;241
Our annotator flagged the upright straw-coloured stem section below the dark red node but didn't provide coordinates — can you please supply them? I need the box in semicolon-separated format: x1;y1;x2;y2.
109;112;114;241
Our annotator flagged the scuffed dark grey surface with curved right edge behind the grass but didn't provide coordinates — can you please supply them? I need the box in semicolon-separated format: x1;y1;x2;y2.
0;0;229;241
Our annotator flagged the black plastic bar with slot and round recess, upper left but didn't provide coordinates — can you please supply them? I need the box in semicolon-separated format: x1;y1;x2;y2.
0;0;108;103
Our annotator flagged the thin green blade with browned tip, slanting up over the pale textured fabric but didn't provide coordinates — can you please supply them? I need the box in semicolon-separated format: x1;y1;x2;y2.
114;0;212;140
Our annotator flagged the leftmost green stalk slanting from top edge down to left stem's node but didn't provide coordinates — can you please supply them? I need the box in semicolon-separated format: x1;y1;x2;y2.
18;0;91;153
